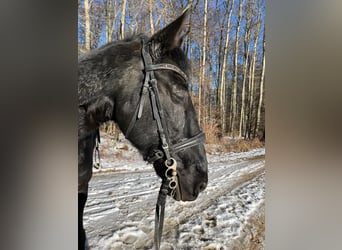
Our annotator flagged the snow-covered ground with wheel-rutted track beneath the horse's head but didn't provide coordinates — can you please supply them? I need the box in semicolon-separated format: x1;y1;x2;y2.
84;132;265;250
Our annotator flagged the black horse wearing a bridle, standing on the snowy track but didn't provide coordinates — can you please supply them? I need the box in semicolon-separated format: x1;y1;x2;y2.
78;11;208;249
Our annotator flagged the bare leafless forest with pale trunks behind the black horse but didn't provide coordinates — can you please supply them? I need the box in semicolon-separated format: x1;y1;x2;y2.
78;0;265;143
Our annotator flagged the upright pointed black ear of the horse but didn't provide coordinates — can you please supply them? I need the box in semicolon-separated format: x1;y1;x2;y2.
151;8;189;54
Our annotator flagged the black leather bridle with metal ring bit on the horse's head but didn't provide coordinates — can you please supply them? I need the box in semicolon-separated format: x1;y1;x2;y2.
125;39;205;249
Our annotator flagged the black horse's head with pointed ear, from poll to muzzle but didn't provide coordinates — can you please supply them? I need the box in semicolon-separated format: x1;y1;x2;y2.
119;12;208;201
